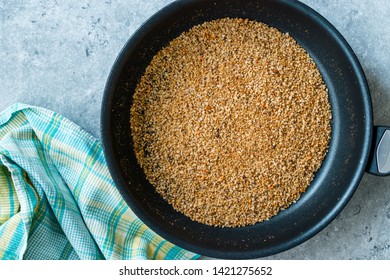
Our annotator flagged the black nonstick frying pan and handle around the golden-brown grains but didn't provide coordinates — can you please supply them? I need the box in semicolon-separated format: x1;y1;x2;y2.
102;0;390;259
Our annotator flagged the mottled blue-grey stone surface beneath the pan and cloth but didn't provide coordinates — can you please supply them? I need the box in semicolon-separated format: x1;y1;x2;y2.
0;0;390;259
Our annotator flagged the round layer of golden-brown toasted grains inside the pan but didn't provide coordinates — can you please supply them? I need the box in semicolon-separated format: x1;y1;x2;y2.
130;18;332;227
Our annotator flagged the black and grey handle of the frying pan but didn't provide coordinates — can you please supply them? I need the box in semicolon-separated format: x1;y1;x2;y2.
366;126;390;176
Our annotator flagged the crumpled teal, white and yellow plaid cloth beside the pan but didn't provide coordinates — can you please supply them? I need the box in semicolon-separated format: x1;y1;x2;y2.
0;104;199;260
